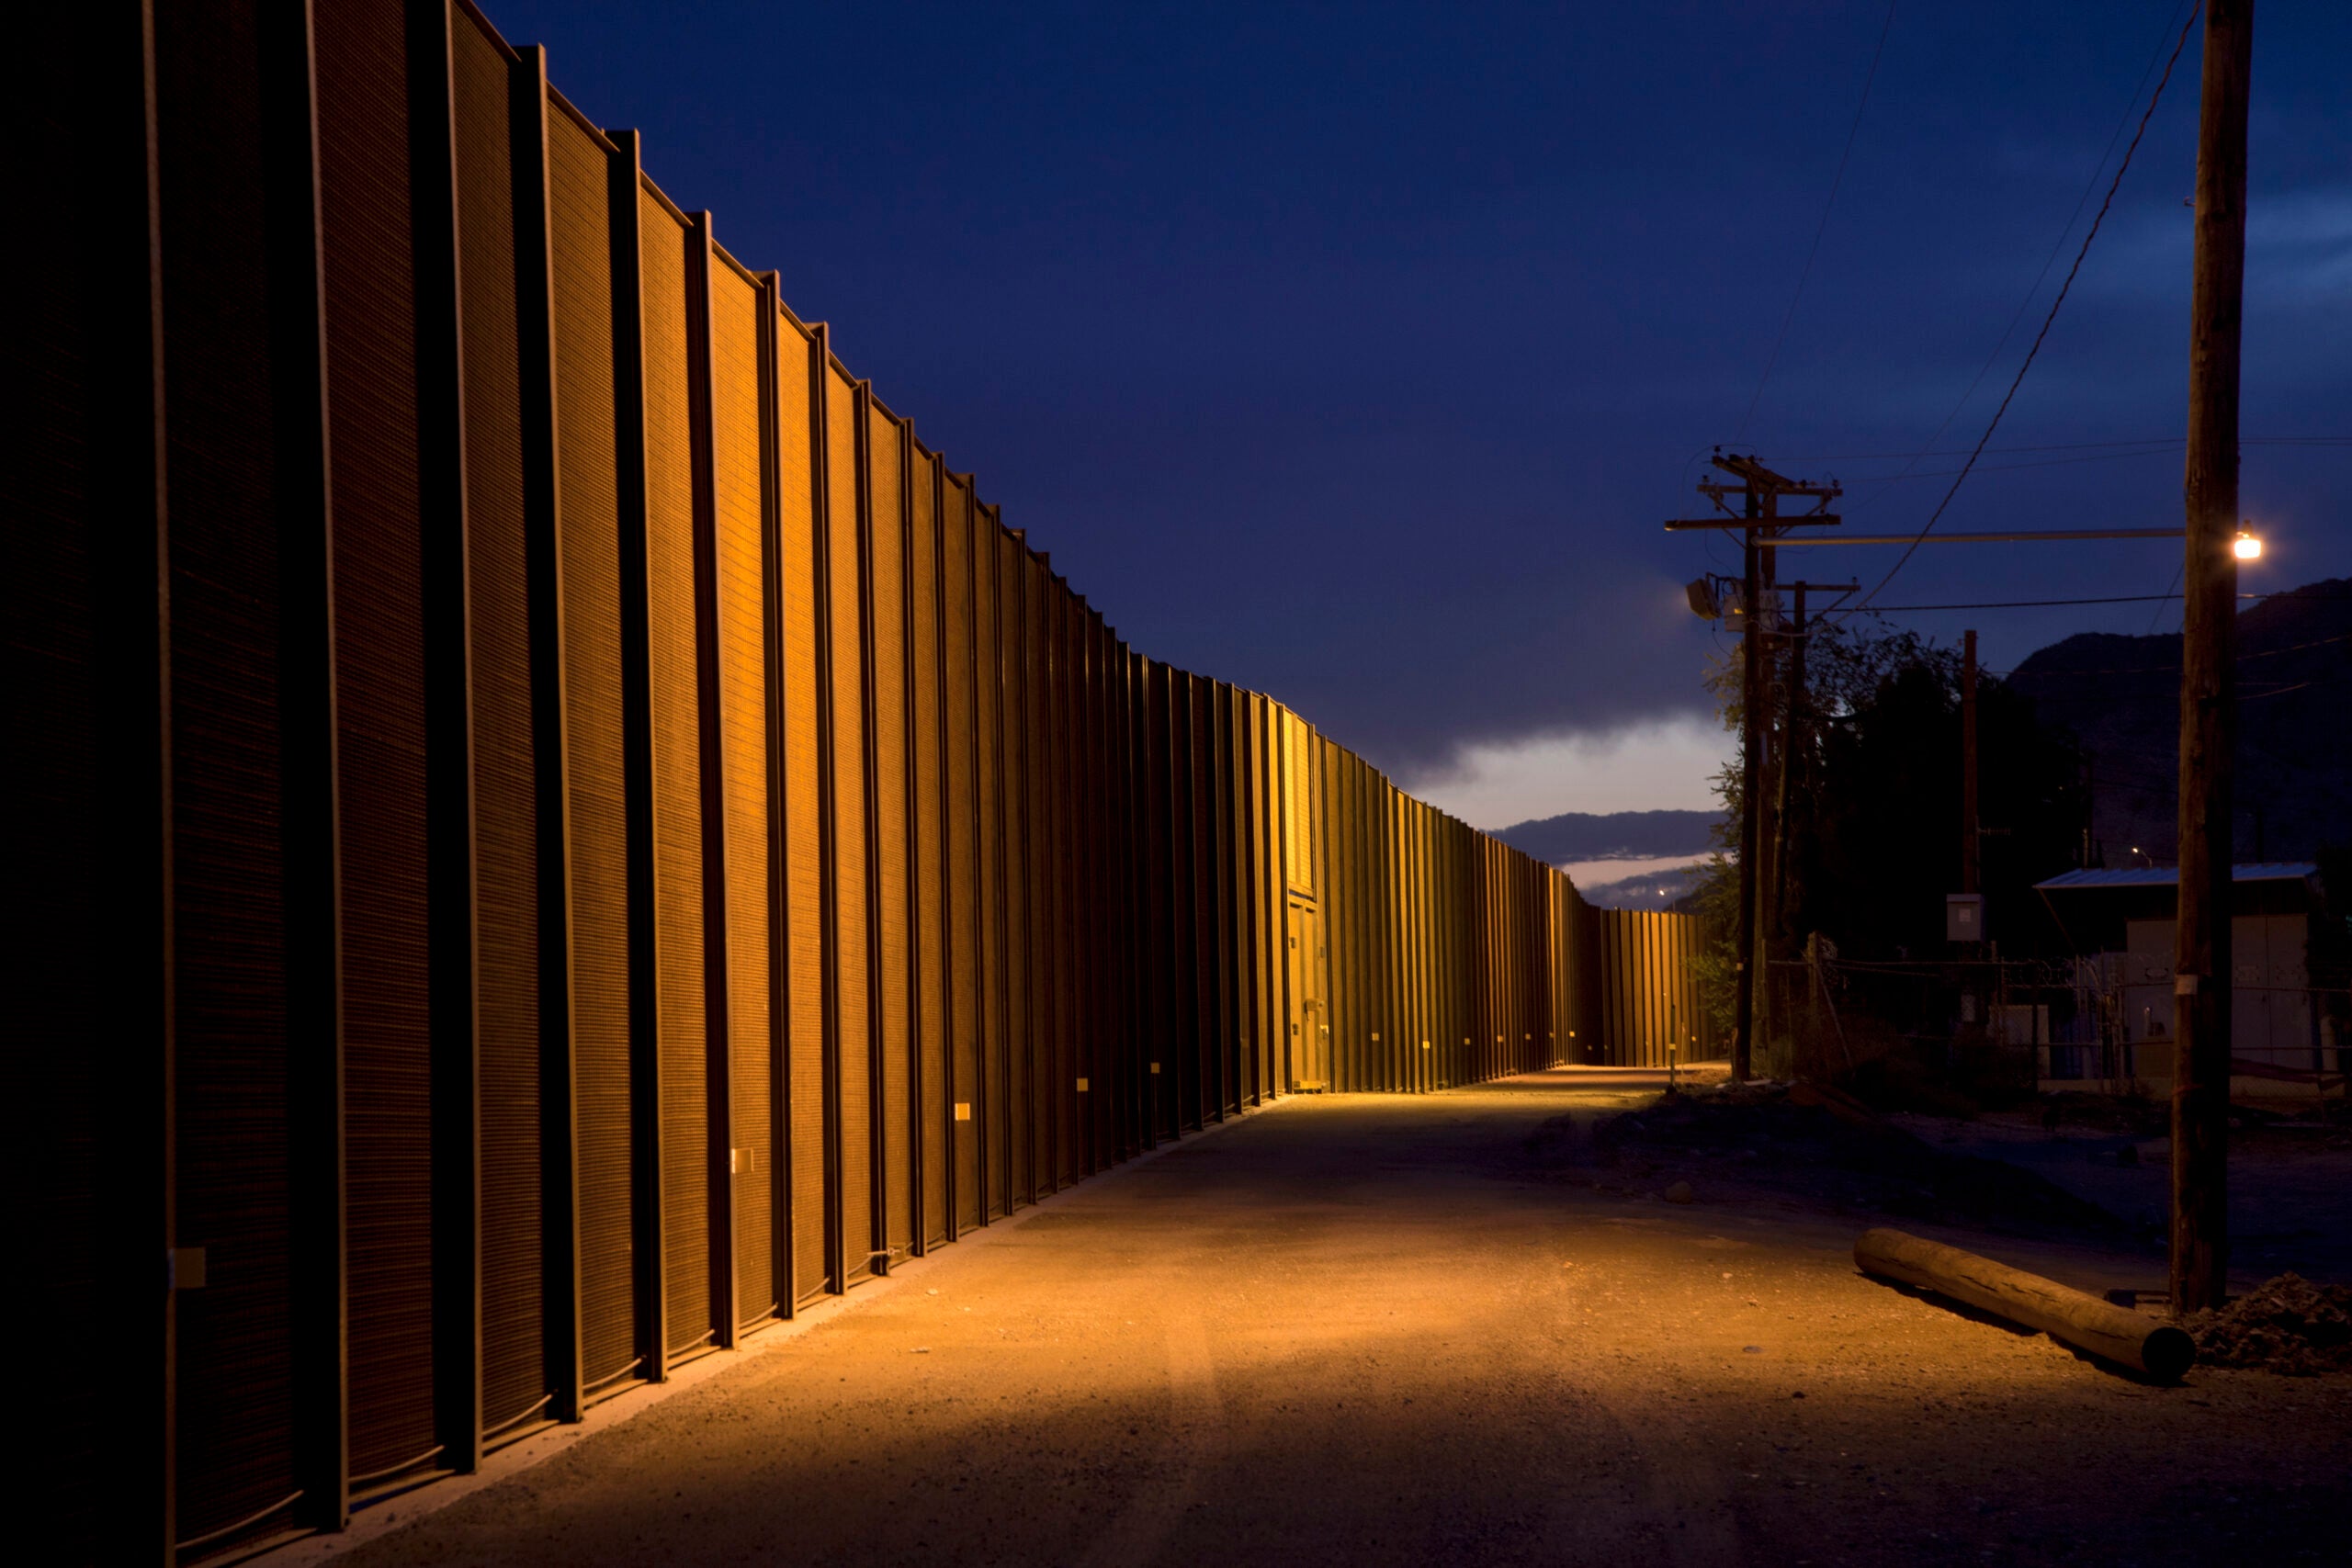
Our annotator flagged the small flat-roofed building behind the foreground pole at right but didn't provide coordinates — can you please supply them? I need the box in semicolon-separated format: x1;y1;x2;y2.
2034;861;2352;1098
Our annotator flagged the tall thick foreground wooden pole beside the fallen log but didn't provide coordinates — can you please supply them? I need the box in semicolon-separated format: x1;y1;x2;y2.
2171;0;2253;1312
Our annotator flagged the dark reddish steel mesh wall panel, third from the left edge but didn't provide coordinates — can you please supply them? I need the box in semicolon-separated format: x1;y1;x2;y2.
315;9;442;1476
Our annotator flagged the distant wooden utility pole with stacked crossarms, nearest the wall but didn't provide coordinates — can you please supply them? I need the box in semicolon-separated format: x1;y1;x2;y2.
1665;451;1844;1079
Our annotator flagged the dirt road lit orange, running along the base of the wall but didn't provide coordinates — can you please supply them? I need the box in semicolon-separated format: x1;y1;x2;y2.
308;1077;2352;1568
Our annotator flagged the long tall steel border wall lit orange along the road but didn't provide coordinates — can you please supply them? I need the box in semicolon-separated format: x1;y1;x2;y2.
5;0;1710;1563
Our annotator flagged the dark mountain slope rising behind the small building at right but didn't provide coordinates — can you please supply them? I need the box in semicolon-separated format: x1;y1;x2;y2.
2008;579;2352;865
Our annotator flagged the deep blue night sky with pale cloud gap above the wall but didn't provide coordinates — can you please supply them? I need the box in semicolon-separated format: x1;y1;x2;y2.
489;0;2352;828
